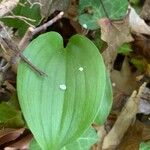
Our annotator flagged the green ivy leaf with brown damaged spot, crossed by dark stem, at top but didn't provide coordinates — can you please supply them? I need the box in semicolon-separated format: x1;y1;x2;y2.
79;0;128;30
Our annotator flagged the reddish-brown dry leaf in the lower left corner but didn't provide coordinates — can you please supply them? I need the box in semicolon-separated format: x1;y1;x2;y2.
0;128;25;145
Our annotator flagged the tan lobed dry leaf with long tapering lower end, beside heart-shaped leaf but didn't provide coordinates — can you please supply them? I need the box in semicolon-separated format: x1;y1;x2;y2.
98;16;133;72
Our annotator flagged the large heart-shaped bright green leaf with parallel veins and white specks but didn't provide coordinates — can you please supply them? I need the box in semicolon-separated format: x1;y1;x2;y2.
17;32;106;150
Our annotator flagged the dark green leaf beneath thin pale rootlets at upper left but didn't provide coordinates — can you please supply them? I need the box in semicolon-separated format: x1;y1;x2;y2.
1;0;42;36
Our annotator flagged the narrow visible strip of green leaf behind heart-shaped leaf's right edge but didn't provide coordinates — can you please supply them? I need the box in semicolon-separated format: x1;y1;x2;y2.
95;73;113;125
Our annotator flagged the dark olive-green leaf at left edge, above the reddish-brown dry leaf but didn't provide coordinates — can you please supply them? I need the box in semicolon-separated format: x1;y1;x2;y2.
0;102;24;128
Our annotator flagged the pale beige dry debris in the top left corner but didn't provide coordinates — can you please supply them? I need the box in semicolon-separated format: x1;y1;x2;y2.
0;0;19;17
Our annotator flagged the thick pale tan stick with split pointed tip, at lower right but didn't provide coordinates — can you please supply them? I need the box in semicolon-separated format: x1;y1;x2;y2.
102;83;146;149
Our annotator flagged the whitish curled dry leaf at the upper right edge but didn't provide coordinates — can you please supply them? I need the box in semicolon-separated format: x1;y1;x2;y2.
129;6;150;35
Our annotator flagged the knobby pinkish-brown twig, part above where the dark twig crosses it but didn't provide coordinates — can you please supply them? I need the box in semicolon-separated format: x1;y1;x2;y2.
19;12;64;50
